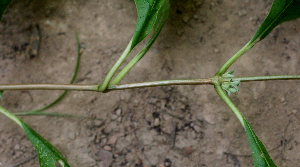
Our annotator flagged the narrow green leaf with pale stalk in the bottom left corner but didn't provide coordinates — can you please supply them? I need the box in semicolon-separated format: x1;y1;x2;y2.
0;106;69;167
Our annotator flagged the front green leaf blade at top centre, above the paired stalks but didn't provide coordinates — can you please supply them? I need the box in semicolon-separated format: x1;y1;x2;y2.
131;0;169;49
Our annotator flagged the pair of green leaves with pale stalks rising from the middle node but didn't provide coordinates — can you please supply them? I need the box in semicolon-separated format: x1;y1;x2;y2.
98;0;170;92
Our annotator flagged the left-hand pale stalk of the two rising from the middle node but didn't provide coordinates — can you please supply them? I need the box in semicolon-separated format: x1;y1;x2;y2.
98;39;132;92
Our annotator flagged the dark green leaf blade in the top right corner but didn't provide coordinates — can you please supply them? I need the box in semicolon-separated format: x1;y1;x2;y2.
250;0;300;43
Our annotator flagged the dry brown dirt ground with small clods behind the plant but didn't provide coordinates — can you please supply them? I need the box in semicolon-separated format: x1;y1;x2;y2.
0;0;300;167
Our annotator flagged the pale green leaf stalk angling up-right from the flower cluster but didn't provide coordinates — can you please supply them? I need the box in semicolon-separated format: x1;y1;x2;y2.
215;42;254;76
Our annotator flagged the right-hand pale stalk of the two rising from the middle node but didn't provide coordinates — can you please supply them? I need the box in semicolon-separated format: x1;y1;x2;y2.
110;45;151;85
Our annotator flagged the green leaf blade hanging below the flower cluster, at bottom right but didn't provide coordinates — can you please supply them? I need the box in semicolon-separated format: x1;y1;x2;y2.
244;119;276;167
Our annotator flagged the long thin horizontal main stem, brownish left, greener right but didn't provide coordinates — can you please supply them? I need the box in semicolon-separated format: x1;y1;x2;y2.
0;75;300;91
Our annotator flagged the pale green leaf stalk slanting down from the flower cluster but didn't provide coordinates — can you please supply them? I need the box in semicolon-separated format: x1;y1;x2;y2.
215;83;245;128
